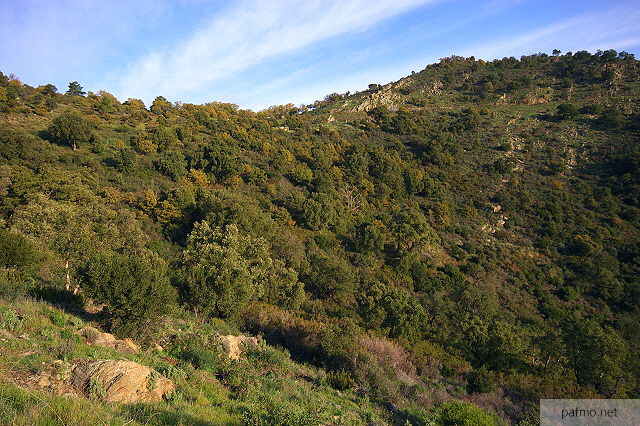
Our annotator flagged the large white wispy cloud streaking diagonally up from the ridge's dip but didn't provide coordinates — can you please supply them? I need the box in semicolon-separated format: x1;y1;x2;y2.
115;0;432;100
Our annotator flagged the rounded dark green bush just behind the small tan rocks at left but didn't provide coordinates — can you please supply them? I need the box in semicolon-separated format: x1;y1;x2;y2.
80;253;176;332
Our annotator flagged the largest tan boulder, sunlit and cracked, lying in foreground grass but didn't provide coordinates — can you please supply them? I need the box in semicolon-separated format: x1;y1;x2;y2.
71;359;175;404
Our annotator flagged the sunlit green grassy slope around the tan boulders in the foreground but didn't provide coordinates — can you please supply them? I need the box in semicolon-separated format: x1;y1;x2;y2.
0;299;391;425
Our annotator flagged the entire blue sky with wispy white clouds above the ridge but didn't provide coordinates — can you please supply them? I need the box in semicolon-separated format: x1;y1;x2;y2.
0;0;640;110
